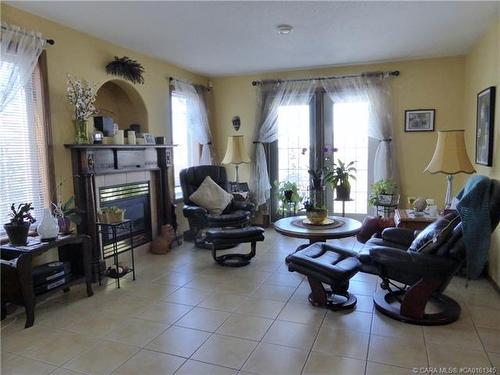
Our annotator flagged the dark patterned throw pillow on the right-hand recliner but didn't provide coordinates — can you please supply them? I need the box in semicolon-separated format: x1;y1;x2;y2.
409;214;460;254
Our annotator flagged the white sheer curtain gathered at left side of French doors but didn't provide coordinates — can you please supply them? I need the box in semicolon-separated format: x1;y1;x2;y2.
250;80;317;206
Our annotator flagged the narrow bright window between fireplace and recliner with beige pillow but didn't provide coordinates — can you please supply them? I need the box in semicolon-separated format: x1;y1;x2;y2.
171;91;199;199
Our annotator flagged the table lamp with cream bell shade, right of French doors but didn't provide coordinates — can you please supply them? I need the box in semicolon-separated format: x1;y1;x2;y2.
425;130;476;209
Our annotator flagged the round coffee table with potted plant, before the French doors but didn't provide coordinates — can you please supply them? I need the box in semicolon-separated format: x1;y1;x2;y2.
274;216;361;244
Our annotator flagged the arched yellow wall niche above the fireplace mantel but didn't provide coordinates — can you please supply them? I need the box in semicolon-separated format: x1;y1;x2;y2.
95;79;149;132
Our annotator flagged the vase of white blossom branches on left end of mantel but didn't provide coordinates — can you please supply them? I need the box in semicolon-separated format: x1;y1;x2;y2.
66;75;97;144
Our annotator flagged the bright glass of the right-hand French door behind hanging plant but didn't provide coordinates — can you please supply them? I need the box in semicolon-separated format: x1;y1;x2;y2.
333;102;368;214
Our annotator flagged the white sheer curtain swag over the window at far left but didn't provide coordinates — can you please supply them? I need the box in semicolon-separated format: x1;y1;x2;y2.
0;22;45;112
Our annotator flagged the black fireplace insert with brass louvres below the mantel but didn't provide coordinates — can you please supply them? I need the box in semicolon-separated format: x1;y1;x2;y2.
98;181;152;257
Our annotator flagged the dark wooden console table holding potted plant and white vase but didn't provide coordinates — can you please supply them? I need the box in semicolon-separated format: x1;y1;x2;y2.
0;235;94;328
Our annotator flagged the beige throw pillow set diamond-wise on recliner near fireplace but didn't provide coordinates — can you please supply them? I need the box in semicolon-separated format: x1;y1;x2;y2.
189;176;233;215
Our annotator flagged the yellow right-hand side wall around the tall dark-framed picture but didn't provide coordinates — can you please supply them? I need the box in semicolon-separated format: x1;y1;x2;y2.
464;19;500;284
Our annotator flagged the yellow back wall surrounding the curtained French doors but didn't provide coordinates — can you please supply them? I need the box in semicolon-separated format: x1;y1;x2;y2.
213;57;466;209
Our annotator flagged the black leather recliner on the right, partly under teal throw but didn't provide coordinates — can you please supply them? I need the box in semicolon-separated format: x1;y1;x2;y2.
326;180;500;325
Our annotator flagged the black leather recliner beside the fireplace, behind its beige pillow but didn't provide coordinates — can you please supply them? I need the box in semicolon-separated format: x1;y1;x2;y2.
180;165;255;248
